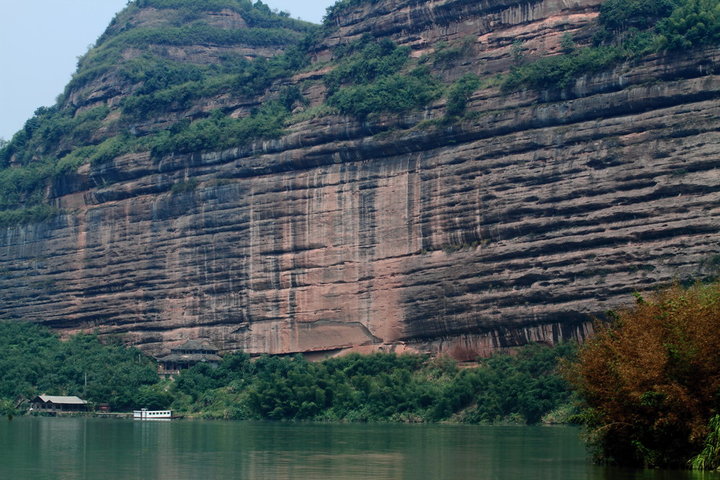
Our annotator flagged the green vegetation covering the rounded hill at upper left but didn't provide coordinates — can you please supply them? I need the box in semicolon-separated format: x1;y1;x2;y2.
0;0;317;225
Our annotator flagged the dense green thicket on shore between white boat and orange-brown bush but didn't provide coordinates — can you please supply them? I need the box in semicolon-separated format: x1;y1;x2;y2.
165;345;575;424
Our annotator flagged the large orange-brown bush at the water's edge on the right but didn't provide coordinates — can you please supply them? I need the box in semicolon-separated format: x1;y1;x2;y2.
568;283;720;467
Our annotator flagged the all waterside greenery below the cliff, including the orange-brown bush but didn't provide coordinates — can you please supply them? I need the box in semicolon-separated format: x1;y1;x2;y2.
0;281;720;469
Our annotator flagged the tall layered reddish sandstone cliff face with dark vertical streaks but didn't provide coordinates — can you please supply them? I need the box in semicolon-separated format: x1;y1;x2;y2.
0;0;720;359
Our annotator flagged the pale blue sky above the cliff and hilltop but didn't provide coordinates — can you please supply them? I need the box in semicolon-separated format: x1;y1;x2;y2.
0;0;335;140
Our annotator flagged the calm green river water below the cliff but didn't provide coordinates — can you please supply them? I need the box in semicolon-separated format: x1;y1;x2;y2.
0;418;720;480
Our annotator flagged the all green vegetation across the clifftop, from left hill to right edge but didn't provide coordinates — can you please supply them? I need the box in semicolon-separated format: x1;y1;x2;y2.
0;0;720;225
